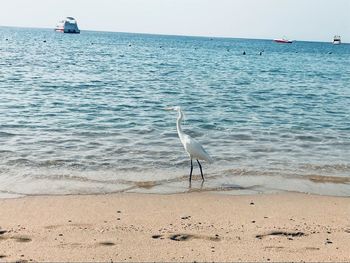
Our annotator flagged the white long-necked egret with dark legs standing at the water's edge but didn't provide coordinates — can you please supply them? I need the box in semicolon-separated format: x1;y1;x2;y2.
166;106;213;183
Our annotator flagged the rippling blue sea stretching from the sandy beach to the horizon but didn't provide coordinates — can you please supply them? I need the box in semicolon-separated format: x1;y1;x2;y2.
0;27;350;197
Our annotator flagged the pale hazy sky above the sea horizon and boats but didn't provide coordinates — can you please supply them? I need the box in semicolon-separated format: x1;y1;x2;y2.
0;0;350;43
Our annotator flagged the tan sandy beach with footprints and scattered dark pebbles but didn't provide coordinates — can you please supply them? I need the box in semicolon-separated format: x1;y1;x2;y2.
0;193;350;262
